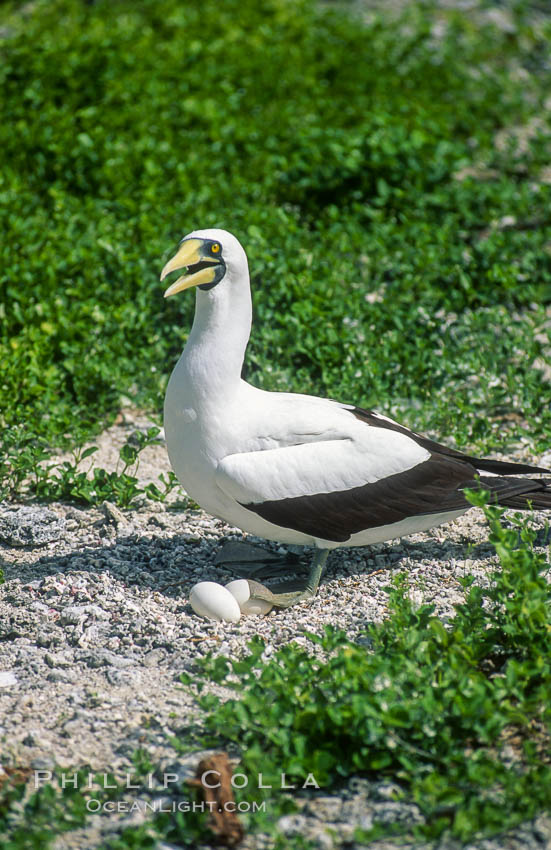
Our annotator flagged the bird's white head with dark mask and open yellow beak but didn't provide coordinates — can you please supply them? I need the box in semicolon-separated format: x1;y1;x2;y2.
161;228;247;298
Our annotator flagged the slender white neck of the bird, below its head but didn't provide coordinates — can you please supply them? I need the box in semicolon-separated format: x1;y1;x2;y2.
182;281;252;404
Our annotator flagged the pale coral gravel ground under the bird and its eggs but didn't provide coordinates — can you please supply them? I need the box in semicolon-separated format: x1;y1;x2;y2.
0;411;551;850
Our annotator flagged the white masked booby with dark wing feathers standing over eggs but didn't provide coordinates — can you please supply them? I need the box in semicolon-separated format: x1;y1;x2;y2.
161;229;551;607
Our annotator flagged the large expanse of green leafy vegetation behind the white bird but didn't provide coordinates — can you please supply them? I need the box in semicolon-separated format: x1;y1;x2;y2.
0;0;551;500
